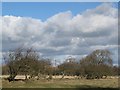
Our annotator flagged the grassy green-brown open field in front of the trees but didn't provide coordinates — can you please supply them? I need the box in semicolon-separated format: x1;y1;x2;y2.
2;76;118;88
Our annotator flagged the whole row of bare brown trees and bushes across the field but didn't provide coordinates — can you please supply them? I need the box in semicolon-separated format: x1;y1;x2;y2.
2;48;120;81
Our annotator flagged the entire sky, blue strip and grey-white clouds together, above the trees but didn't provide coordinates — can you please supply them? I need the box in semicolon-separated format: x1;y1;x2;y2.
2;2;118;64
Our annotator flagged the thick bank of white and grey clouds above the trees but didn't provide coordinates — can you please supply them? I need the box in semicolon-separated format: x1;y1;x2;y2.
2;3;118;63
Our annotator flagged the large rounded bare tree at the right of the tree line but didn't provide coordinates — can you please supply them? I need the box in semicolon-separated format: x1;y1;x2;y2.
80;50;112;79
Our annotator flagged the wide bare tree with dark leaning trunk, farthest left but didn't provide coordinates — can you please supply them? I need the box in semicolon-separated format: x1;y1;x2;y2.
4;47;39;81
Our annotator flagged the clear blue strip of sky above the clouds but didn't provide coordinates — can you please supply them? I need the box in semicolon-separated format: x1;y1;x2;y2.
2;2;100;21
